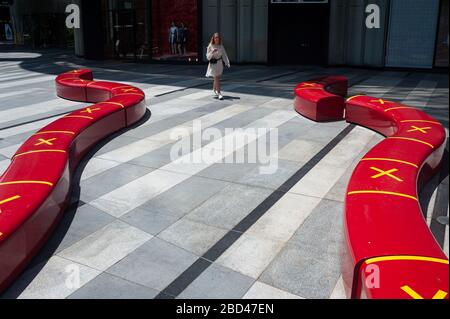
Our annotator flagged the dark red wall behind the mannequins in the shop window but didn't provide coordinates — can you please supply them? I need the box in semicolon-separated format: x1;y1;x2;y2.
152;0;198;54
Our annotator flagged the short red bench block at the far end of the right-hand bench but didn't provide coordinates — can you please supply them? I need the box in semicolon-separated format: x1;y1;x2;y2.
294;76;348;122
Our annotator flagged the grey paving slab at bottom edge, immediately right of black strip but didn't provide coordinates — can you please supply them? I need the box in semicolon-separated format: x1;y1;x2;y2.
178;264;254;299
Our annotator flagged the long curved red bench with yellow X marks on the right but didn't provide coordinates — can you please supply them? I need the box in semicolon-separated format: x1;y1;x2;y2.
342;96;449;299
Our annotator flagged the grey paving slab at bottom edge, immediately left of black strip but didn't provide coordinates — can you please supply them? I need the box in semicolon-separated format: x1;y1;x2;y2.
68;273;158;299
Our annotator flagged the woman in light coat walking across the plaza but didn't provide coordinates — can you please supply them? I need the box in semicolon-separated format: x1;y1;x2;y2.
206;33;231;100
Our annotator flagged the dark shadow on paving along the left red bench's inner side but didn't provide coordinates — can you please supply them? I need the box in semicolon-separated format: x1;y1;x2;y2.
0;109;151;299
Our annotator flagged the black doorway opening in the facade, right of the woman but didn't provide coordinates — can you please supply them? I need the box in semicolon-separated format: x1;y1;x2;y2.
269;3;330;65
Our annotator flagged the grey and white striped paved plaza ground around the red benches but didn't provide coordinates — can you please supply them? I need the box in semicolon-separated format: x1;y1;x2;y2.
0;51;449;298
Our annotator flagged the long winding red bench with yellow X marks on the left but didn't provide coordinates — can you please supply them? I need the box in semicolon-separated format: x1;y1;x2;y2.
0;69;146;291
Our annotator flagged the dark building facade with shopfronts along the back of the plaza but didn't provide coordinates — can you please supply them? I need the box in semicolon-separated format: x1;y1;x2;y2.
0;0;449;69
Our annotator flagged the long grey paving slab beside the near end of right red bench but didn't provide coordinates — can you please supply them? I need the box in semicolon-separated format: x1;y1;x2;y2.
261;200;343;298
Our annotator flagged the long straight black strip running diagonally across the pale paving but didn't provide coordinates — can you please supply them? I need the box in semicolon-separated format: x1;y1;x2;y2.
155;124;355;299
